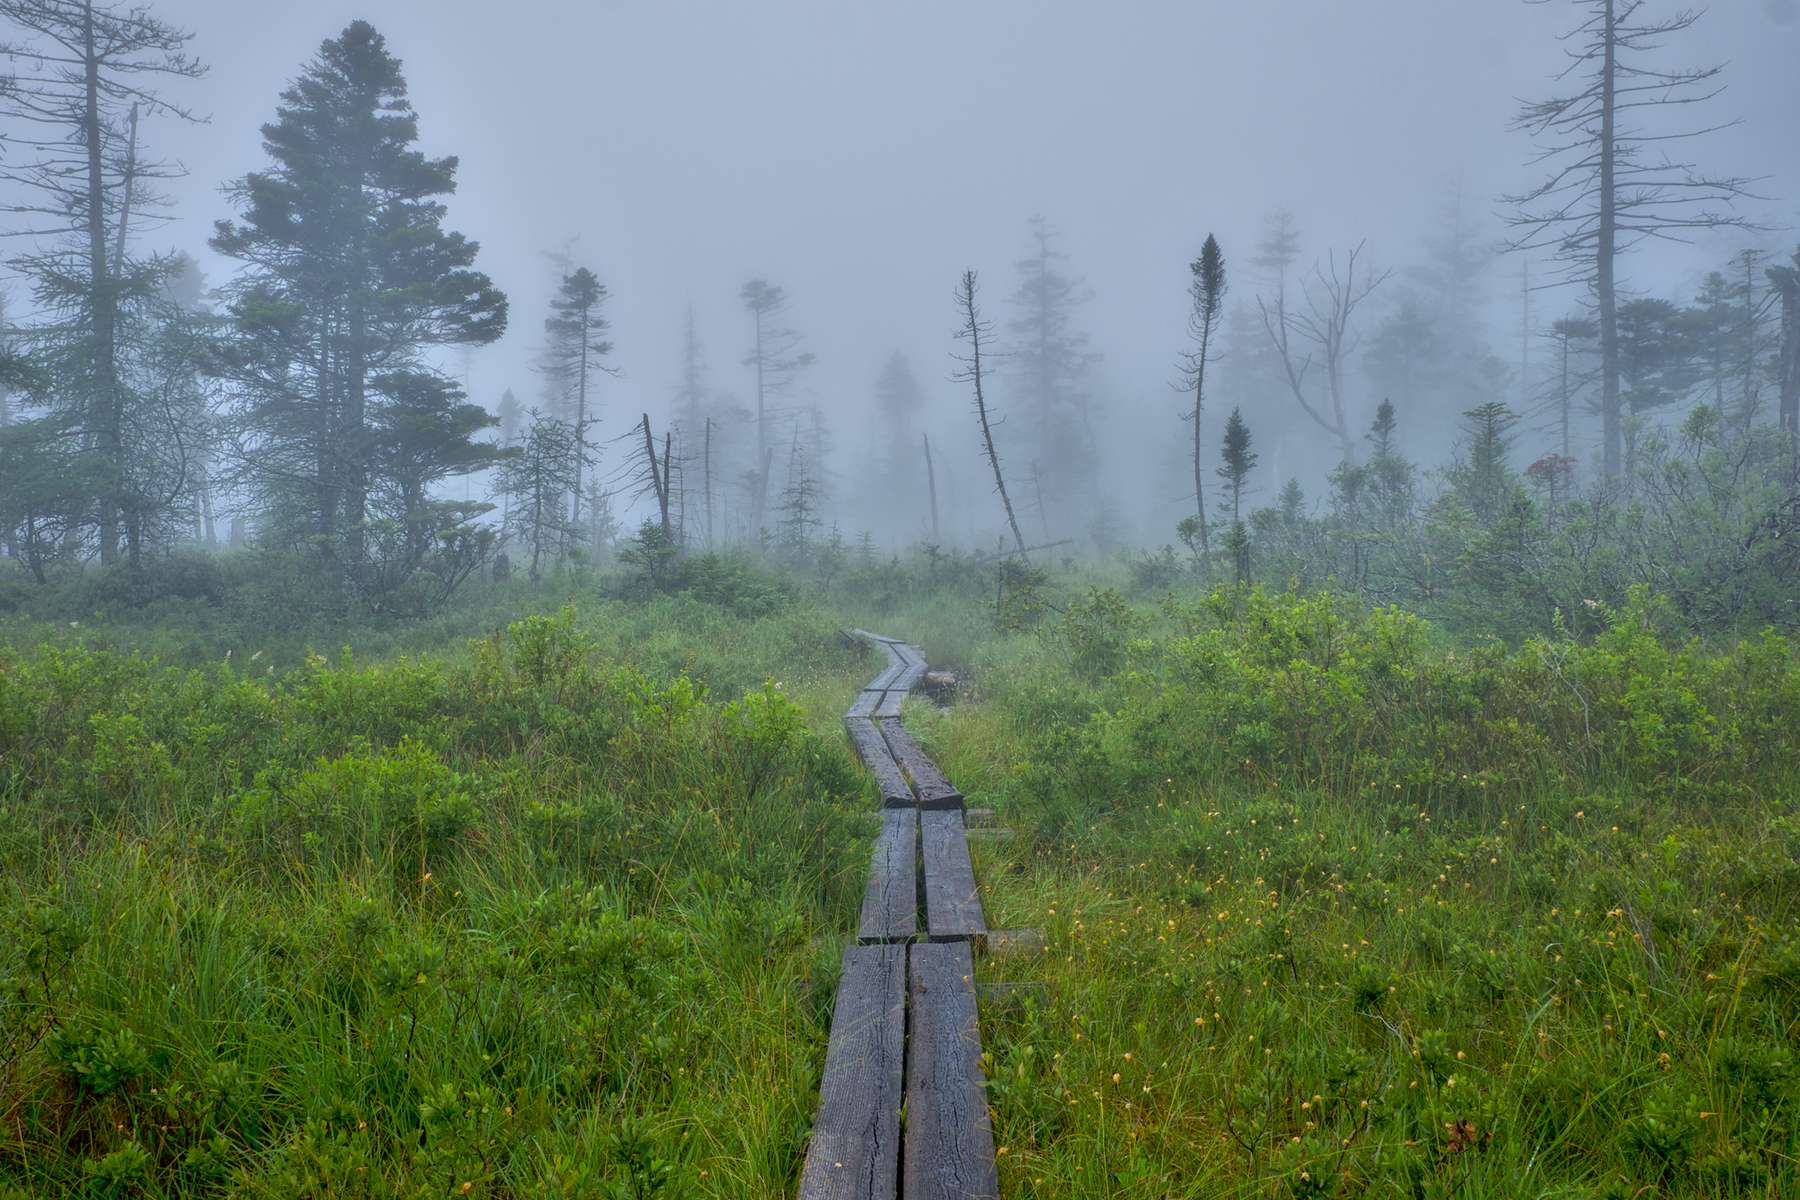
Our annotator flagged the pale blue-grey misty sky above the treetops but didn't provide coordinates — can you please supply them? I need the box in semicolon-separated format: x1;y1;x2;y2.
21;0;1800;528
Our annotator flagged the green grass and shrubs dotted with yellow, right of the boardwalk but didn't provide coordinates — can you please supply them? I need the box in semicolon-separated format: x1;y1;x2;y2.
913;594;1800;1198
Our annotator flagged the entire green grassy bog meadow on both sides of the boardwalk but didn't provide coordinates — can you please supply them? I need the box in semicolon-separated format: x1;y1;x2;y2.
0;565;1800;1200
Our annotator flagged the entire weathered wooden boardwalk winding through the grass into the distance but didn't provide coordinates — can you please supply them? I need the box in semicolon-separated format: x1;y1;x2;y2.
799;630;999;1200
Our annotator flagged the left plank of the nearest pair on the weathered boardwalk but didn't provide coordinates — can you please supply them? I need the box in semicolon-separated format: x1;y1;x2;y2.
799;945;905;1200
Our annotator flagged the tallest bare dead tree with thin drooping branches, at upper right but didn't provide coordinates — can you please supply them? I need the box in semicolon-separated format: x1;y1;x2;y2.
1505;0;1753;479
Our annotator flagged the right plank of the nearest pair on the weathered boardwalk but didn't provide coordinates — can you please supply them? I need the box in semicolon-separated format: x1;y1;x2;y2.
900;949;1001;1200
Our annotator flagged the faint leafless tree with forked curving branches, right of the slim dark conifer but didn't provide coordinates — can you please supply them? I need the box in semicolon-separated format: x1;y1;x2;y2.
1256;241;1393;461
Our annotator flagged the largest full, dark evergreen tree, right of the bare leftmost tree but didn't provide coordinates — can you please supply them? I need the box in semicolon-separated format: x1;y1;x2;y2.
212;22;506;603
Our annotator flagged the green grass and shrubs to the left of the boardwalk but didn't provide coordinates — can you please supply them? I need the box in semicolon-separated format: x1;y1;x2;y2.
0;601;873;1196
